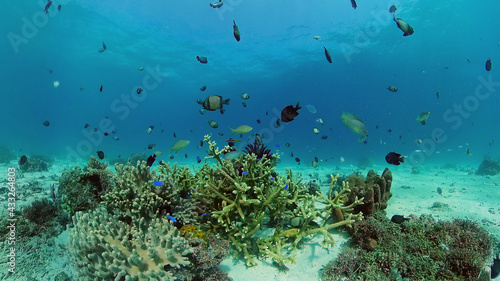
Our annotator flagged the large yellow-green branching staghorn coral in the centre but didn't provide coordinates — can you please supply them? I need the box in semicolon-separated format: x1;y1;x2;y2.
191;136;362;267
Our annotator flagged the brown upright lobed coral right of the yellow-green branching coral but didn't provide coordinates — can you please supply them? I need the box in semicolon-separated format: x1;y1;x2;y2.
347;168;392;218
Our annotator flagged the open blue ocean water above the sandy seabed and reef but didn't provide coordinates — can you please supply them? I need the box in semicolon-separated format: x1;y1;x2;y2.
0;0;500;165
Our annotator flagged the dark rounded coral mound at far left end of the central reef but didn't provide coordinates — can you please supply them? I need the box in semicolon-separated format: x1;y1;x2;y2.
57;157;113;215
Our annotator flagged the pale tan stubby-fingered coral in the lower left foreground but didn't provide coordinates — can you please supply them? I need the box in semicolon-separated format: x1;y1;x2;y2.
69;208;193;281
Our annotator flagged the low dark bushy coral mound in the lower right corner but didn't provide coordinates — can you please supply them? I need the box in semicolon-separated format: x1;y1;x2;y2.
321;211;493;281
